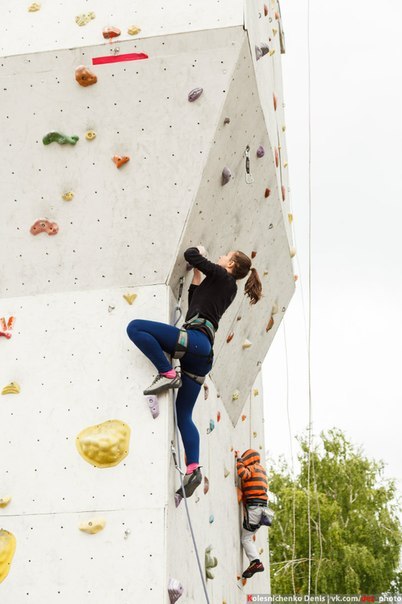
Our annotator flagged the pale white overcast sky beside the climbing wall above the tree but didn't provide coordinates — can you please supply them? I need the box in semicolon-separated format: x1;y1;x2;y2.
263;0;402;491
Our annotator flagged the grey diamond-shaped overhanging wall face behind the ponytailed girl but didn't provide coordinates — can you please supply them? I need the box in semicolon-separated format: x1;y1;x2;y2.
171;37;294;424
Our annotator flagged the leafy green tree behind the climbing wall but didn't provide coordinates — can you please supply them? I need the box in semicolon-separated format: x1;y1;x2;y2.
269;429;402;595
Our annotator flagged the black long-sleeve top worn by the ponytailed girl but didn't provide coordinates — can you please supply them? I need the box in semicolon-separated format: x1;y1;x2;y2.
184;247;237;329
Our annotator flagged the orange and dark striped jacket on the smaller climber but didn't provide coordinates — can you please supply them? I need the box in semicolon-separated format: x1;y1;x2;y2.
237;449;268;503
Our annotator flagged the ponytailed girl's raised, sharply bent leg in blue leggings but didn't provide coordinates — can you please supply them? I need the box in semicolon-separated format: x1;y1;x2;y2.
127;319;179;373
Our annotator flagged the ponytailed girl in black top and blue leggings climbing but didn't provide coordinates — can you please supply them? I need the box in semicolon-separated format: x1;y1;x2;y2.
127;246;262;497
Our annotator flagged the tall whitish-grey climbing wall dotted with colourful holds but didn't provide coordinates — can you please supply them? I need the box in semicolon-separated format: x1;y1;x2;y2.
0;0;288;604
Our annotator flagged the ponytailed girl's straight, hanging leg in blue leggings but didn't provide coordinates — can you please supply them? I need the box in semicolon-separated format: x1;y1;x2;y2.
176;374;201;466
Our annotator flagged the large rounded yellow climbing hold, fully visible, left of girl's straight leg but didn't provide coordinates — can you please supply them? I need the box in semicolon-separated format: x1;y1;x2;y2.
76;419;130;468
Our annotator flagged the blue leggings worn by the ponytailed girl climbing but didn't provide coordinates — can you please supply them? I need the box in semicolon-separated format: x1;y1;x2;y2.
127;319;212;465
